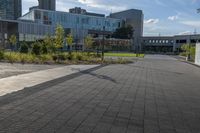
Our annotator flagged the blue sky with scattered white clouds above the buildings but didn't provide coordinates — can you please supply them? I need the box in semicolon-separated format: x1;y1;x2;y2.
22;0;200;36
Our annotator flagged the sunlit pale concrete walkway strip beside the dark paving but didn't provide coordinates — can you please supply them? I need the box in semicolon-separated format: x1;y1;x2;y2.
0;65;97;96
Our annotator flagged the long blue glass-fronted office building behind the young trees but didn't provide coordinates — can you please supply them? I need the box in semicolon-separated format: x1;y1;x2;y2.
18;9;122;43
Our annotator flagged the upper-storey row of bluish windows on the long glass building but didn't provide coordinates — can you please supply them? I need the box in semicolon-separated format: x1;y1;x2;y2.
34;10;120;29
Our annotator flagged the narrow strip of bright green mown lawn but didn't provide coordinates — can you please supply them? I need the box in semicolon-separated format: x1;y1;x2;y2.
105;53;144;58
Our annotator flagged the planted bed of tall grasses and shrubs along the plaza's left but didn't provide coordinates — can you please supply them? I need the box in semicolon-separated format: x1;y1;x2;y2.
0;51;133;64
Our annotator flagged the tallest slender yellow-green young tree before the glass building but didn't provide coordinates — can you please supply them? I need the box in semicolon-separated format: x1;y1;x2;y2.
55;25;65;49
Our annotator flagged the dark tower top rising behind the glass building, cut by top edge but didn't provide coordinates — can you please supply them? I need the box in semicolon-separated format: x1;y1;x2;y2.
38;0;56;11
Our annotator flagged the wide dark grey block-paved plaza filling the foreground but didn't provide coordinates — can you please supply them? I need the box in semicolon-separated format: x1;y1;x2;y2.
0;55;200;133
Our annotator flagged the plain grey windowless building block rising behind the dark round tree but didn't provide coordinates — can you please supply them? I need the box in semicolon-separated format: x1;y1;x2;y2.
110;9;144;52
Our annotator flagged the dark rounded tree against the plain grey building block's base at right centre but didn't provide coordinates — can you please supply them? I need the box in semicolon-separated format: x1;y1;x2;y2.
112;25;134;39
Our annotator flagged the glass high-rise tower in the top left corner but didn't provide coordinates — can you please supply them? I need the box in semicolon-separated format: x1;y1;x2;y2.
0;0;22;20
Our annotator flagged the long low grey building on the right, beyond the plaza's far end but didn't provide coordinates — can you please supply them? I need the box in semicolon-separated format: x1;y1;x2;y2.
142;34;200;53
